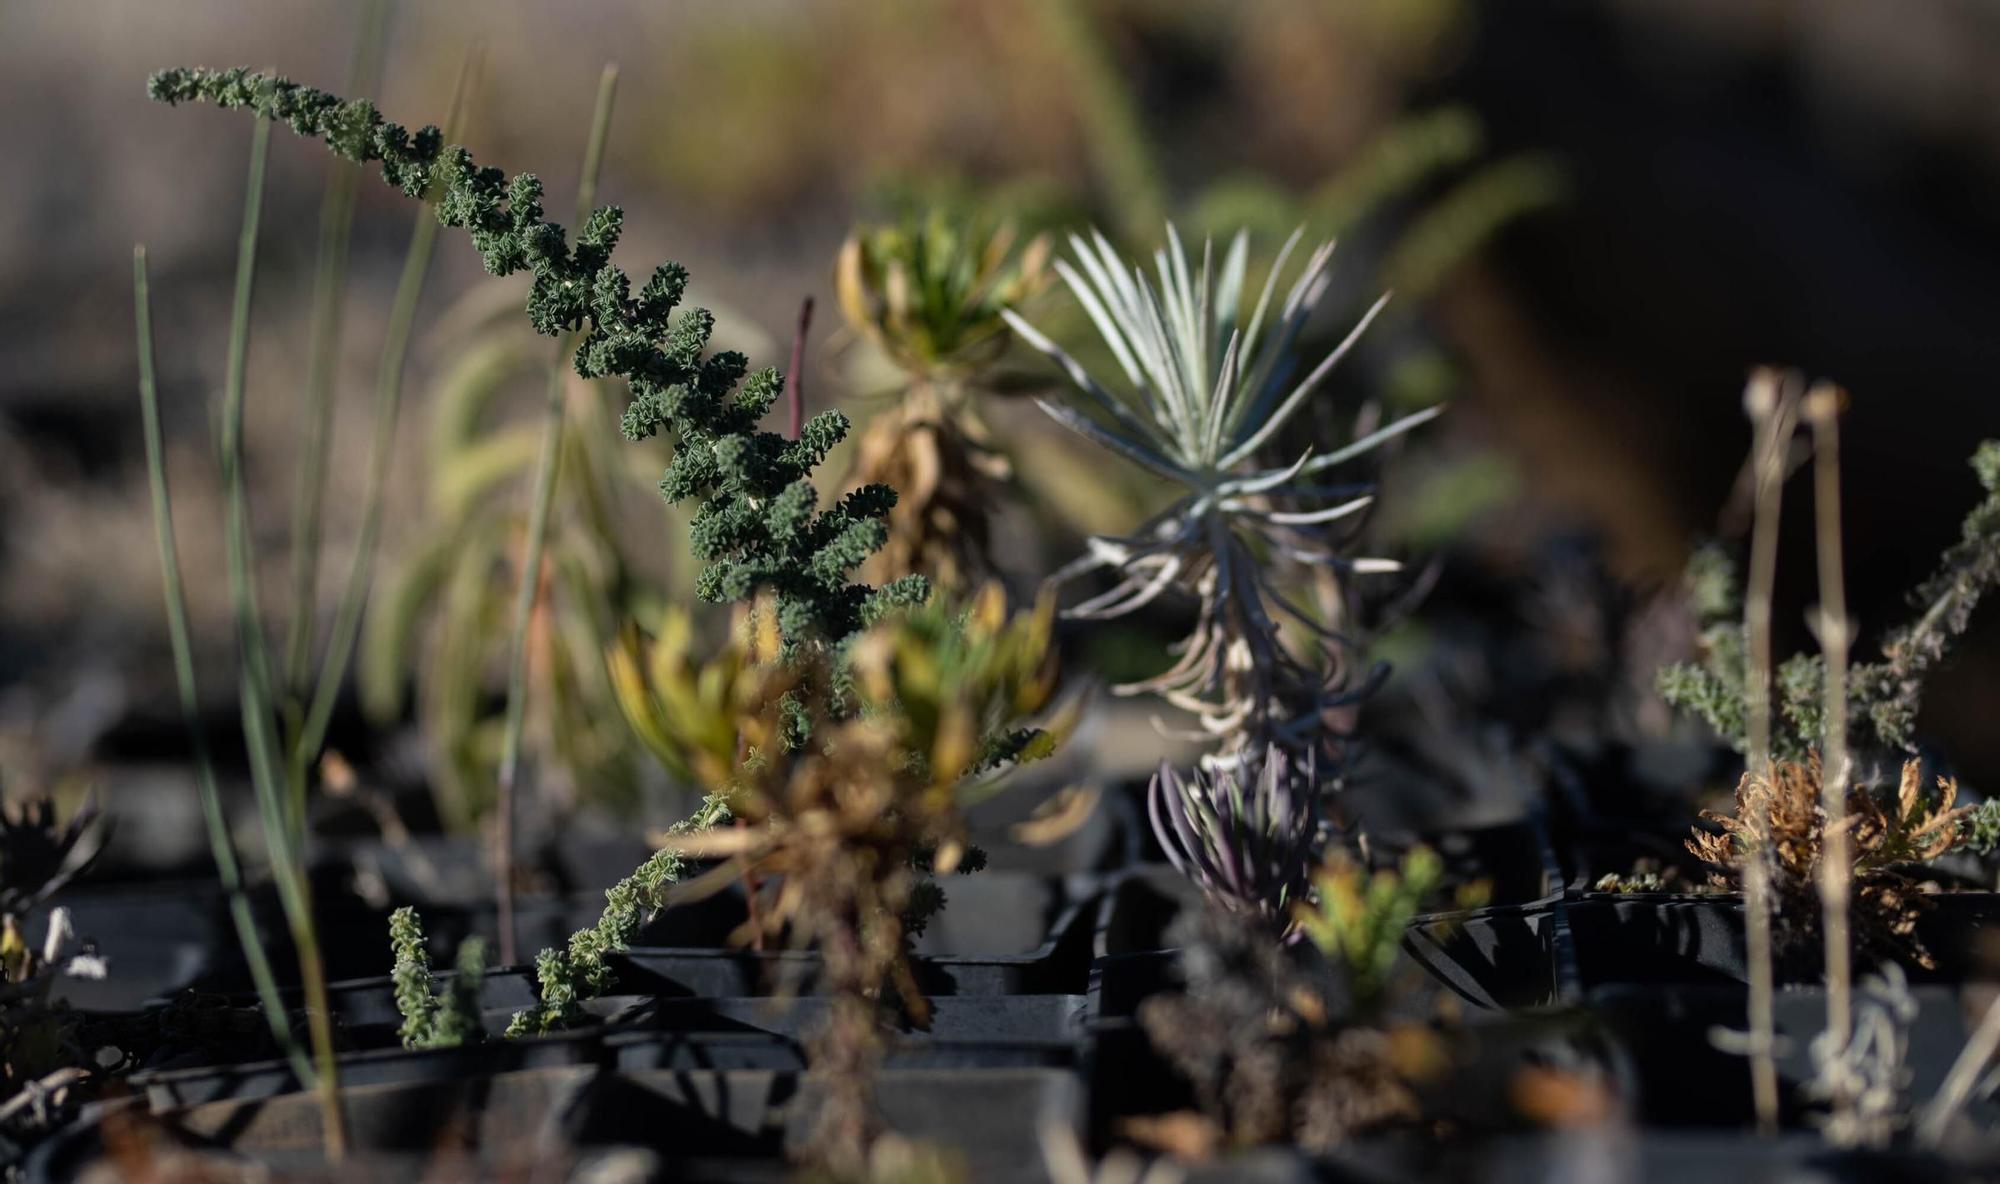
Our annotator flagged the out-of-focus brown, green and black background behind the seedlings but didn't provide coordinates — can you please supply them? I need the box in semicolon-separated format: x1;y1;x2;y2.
0;0;2000;866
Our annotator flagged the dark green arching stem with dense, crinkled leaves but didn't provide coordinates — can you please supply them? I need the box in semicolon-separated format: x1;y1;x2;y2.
148;68;926;646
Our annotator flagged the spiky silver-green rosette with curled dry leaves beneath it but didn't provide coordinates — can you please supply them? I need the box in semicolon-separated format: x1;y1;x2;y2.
1002;226;1438;760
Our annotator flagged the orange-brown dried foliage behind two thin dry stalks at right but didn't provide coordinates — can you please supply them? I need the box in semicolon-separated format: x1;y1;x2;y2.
1688;752;1972;968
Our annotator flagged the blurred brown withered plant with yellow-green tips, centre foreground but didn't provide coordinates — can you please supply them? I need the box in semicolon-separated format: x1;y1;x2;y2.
674;584;1066;1178
